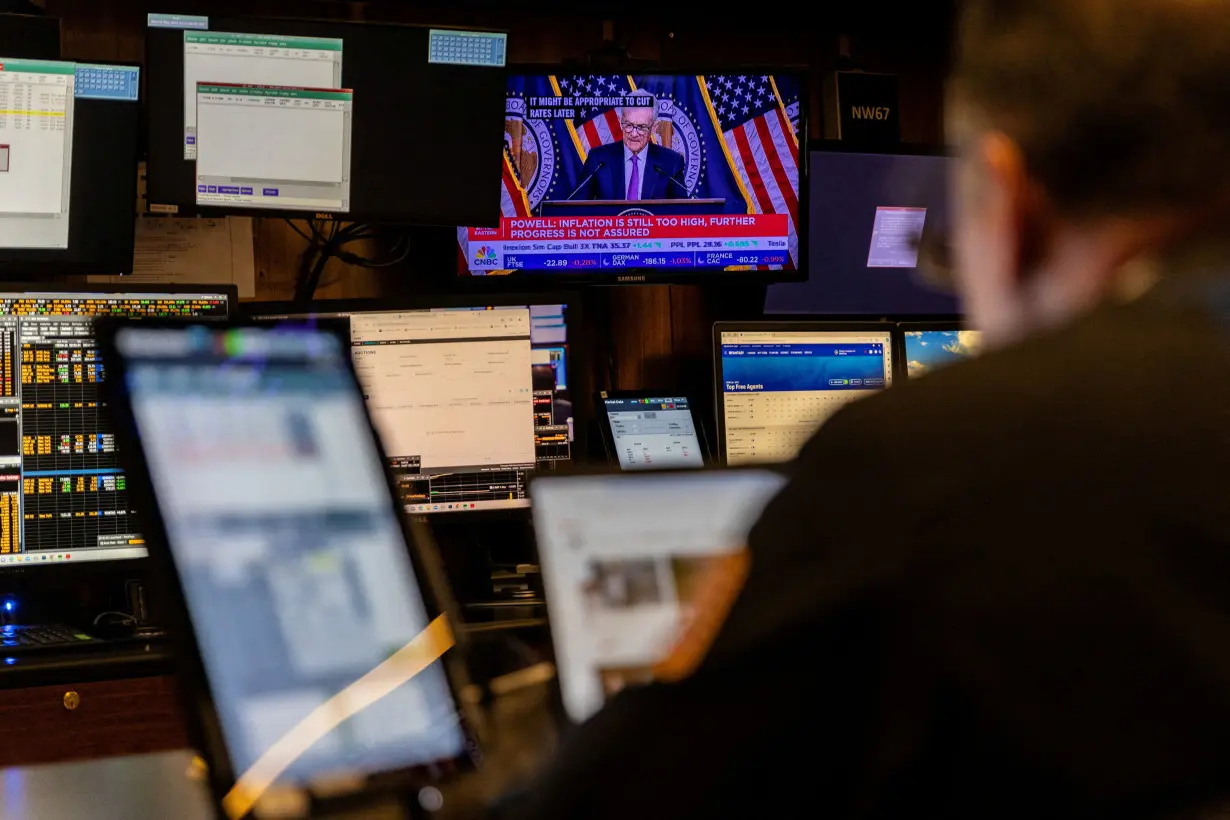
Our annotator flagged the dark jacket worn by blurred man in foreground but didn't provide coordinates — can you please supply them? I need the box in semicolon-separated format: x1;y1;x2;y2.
509;272;1230;820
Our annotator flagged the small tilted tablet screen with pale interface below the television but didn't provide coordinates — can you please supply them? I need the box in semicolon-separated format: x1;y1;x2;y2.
600;396;705;470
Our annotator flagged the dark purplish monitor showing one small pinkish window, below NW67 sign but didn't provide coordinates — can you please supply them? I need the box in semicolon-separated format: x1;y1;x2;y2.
765;144;961;317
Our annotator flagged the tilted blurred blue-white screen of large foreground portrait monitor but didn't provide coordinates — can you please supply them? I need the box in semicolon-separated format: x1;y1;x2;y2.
116;326;466;784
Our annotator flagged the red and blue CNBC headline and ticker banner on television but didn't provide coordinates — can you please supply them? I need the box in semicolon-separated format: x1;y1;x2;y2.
470;213;790;273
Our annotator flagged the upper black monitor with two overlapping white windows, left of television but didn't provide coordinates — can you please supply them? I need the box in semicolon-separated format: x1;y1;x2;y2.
145;14;507;225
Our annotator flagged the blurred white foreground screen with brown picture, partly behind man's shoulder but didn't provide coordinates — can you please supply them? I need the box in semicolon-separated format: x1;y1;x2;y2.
533;470;786;723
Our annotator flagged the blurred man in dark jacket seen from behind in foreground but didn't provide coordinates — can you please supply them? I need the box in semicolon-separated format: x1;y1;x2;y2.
511;0;1230;820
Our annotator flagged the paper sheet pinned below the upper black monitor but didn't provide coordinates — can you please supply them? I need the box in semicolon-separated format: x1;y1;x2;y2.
90;216;256;299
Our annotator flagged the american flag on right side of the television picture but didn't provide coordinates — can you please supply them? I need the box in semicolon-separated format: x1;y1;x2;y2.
704;74;798;268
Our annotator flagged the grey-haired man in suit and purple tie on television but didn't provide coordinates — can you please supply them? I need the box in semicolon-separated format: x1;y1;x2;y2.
569;97;688;200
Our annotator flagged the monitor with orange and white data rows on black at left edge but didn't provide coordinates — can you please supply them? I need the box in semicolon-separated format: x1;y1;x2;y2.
0;285;237;570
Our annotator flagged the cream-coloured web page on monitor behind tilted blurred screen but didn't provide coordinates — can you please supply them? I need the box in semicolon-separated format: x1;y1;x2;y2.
351;309;535;472
